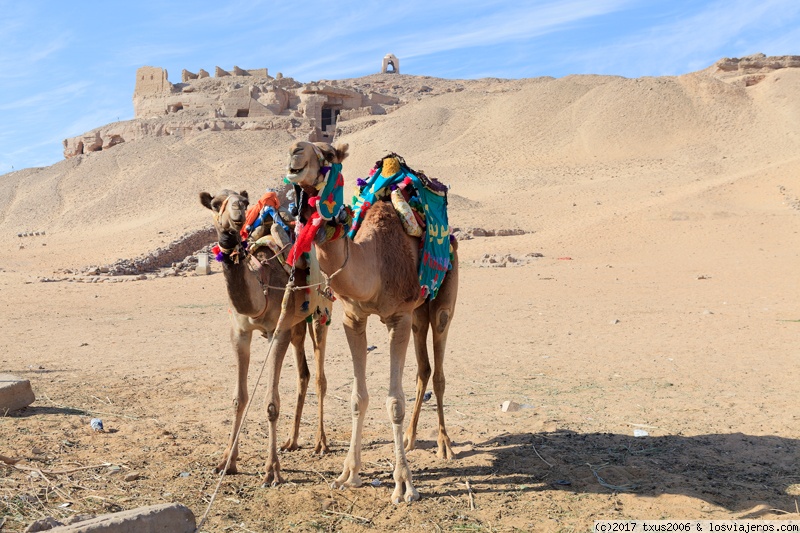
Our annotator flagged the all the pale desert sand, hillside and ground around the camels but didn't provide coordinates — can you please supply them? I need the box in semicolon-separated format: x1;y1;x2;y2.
0;60;800;531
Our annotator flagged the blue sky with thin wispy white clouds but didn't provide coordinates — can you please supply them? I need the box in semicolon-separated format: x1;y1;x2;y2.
0;0;800;174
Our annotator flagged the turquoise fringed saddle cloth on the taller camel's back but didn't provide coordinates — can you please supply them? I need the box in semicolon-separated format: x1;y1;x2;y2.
348;153;452;299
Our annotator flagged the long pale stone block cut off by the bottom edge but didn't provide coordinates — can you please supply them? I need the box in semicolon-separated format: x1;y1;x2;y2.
40;503;195;533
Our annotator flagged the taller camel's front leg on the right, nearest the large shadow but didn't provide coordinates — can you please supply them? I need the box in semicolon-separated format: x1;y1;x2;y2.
386;313;419;503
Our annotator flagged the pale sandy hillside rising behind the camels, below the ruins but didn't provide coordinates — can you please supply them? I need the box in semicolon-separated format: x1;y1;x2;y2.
0;56;800;274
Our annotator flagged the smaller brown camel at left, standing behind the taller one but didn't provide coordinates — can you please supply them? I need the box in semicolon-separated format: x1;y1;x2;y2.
200;189;329;484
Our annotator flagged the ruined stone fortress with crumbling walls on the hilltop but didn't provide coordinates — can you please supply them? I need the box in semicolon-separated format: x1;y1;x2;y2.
64;62;403;158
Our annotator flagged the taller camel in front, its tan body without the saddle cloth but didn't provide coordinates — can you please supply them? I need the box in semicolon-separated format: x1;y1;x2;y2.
287;141;458;503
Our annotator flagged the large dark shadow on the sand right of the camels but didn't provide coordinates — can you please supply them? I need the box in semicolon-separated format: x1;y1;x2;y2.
418;431;800;512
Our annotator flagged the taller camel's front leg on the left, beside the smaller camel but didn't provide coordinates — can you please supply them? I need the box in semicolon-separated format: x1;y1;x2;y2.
331;312;369;488
